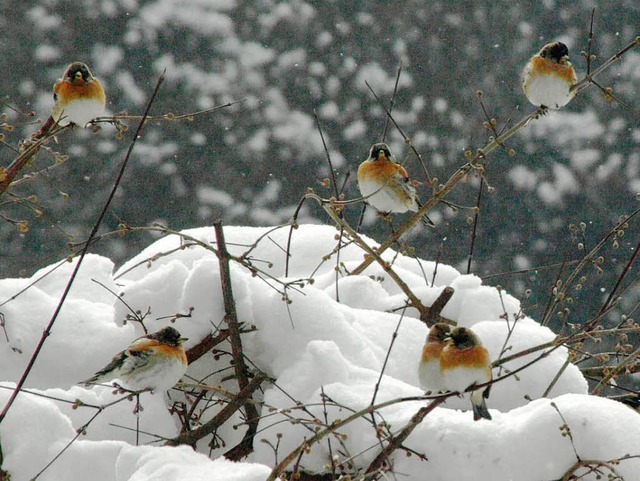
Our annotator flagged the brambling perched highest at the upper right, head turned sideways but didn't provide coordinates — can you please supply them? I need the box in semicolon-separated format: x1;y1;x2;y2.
522;42;577;110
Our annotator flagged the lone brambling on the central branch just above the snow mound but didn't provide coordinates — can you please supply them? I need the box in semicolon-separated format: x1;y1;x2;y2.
358;143;434;226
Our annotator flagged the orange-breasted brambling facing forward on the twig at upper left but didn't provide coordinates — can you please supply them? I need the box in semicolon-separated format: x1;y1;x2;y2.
51;62;107;127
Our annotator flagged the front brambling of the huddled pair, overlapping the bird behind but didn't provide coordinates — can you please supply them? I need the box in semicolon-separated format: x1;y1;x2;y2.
440;327;493;421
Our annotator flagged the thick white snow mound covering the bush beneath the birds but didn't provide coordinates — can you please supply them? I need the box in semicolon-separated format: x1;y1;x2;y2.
0;225;640;481
